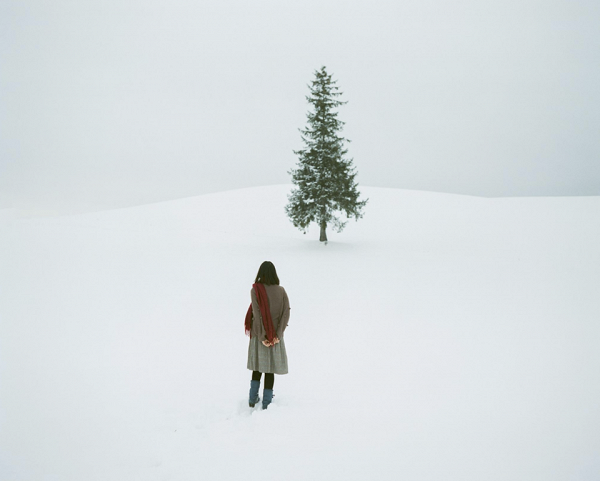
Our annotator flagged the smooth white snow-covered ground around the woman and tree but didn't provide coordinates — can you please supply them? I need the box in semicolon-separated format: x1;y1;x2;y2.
0;186;600;481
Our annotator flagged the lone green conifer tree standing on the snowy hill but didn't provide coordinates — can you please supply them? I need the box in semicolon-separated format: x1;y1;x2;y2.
285;67;367;242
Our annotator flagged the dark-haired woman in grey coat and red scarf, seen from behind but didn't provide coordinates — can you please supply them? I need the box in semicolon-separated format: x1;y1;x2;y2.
245;261;290;409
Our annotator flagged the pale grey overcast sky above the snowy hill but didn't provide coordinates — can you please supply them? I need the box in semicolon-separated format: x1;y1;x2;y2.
0;0;600;210
